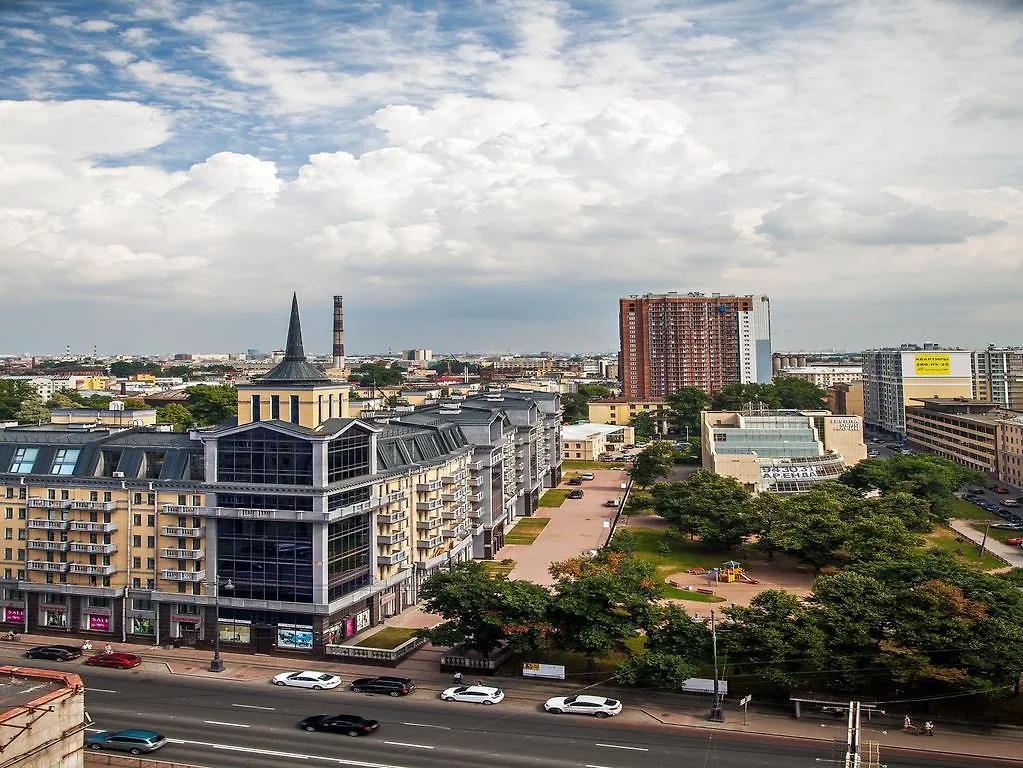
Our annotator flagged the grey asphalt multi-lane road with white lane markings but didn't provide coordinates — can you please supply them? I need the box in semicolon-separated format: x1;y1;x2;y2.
1;661;1006;768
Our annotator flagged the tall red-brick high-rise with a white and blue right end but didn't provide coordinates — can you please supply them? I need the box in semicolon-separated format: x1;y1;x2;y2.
619;292;771;400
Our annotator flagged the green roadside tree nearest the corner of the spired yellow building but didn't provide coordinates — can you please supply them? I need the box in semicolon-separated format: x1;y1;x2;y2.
419;560;550;654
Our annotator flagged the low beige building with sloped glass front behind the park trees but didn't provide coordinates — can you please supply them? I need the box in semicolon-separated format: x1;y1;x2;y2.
701;410;866;493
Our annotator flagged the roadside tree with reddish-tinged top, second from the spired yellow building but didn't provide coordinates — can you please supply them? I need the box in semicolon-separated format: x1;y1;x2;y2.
547;549;661;676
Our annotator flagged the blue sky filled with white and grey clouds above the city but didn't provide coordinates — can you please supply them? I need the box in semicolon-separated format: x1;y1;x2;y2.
0;0;1023;354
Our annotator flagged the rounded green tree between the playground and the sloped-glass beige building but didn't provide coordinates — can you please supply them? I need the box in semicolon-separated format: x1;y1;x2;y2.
653;469;756;549
